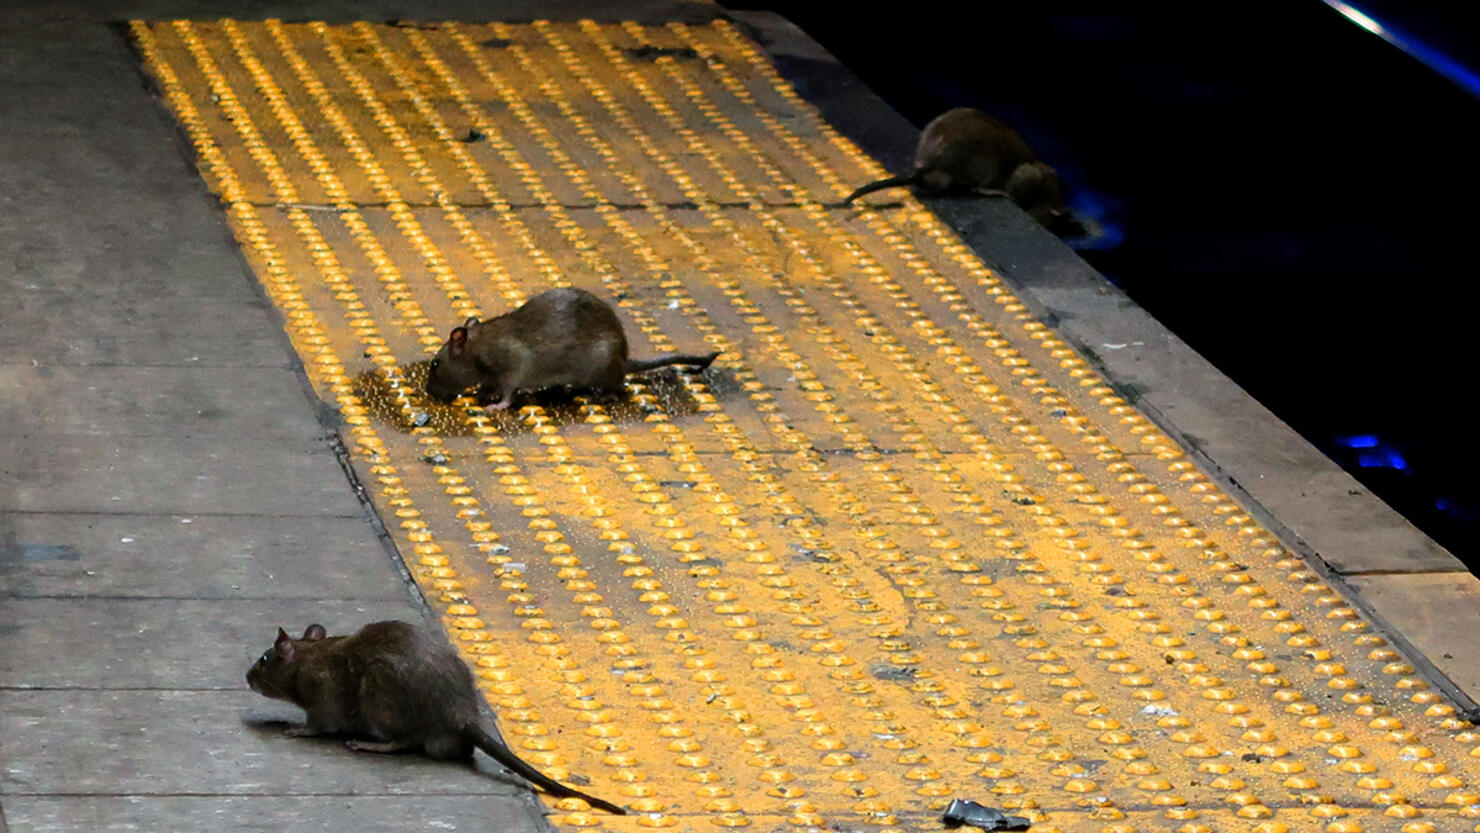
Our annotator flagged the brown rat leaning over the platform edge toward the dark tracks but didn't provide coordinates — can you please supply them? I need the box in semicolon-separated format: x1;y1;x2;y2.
844;107;1077;231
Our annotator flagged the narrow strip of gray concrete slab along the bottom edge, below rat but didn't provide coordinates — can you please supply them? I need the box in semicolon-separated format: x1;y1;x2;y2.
6;795;543;833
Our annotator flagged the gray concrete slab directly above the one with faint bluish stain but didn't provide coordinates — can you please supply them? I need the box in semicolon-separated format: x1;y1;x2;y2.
0;434;364;518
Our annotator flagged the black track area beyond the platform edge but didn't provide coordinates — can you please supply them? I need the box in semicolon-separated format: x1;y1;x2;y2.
727;0;1480;570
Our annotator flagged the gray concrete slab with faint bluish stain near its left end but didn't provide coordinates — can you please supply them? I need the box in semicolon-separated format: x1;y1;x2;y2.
0;512;413;602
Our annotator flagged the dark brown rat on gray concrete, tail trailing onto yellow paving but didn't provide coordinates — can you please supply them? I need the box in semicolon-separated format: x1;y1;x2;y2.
247;621;628;815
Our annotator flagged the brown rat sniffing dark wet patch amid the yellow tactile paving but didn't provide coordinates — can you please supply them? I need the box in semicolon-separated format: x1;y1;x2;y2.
426;289;719;410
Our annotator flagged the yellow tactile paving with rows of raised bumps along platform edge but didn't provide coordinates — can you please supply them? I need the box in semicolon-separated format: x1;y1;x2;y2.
132;21;1480;833
